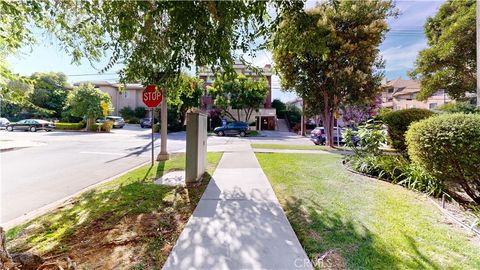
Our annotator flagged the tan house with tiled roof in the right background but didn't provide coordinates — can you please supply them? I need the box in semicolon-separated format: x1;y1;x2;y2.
381;77;452;111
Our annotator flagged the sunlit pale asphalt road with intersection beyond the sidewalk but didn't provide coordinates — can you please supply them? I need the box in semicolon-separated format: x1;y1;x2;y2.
0;126;309;224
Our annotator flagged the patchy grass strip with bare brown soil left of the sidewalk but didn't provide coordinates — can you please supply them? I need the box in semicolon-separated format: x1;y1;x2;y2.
7;153;222;269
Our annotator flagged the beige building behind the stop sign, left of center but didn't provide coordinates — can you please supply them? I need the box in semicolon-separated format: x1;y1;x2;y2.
73;81;146;115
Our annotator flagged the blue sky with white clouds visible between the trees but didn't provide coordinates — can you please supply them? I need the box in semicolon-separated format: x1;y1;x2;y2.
7;0;444;102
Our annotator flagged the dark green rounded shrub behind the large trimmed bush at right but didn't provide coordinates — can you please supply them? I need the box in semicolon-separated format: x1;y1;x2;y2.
383;109;434;151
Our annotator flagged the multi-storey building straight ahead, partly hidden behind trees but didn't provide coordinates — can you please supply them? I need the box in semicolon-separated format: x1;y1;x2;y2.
198;60;277;130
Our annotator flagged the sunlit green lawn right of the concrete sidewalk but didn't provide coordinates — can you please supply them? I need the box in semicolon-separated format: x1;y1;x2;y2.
257;153;480;269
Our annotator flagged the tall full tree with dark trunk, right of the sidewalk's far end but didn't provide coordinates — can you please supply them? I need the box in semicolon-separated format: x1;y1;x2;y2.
270;0;395;146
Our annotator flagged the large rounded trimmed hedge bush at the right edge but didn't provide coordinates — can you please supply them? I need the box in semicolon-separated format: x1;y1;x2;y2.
406;113;480;204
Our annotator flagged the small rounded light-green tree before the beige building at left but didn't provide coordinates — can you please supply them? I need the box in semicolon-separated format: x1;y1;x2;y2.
28;72;68;118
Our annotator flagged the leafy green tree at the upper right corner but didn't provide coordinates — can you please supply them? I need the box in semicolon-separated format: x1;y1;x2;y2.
410;0;477;100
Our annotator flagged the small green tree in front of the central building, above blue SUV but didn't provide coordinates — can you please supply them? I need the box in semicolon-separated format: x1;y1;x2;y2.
208;74;268;123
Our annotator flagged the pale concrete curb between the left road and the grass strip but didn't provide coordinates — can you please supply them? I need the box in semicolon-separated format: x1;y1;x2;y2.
0;161;151;230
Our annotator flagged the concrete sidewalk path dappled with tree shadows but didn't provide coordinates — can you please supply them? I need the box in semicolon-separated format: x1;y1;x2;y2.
163;144;313;270
